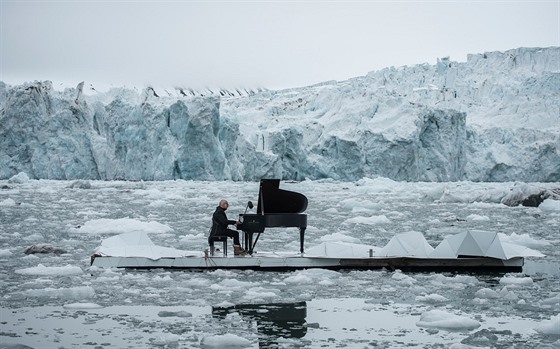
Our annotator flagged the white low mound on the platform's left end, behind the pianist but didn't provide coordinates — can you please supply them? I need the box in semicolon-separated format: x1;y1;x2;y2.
96;232;193;260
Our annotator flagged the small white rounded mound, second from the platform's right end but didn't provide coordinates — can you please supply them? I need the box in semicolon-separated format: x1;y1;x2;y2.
375;231;434;258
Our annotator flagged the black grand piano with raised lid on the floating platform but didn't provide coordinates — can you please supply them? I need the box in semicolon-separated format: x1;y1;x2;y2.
237;179;307;254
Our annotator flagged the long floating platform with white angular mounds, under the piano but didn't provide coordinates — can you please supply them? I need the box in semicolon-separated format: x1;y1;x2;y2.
87;232;543;272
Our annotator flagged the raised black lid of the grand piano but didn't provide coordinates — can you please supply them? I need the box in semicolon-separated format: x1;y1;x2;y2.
257;179;307;214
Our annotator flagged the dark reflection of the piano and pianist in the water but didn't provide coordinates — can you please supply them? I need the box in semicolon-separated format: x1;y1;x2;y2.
212;302;307;348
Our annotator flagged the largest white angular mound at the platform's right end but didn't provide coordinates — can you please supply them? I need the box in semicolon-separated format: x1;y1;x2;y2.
429;230;544;260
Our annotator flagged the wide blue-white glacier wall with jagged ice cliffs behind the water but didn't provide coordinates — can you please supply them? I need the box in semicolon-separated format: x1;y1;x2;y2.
0;47;560;182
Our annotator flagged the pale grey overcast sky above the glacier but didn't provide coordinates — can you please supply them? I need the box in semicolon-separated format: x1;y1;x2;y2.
0;0;560;89
